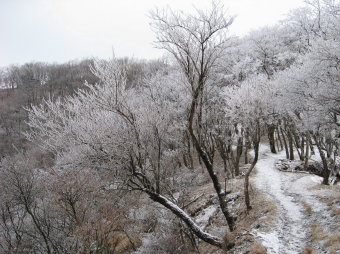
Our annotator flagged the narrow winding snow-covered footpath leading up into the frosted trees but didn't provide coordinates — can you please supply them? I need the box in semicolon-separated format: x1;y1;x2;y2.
255;145;307;254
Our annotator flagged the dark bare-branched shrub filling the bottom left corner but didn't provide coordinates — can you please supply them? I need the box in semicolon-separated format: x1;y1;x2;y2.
0;154;71;253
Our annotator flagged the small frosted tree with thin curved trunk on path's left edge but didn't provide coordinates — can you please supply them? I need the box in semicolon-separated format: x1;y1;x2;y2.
224;76;277;210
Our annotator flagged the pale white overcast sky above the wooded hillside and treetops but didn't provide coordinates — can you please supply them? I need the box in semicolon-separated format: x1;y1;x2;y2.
0;0;303;66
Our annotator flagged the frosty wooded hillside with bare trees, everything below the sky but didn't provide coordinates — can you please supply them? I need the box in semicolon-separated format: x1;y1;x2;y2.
0;0;340;254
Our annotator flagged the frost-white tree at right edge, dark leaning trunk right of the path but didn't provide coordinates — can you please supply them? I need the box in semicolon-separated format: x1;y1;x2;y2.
277;37;340;183
